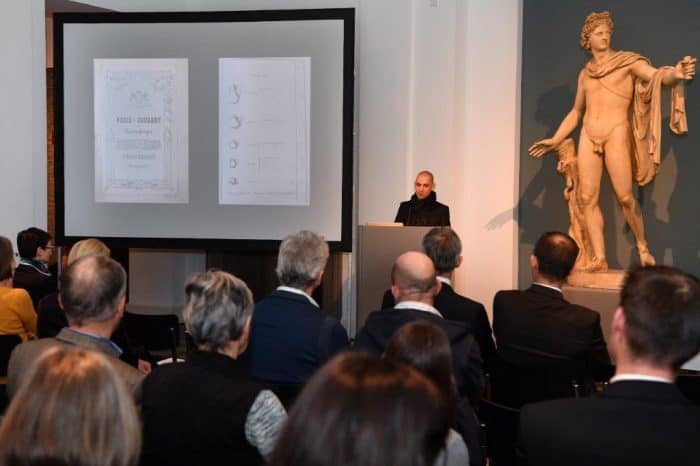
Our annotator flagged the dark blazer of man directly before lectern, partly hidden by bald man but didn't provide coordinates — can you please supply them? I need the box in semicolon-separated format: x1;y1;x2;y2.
382;283;498;373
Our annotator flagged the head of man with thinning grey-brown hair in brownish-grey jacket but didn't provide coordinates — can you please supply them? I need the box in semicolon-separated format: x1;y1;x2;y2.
60;255;126;325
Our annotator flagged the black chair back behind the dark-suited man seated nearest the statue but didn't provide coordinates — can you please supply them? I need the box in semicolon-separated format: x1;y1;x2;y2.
491;351;594;409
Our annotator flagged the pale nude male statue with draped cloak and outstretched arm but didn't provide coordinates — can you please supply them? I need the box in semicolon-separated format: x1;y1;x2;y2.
528;11;696;271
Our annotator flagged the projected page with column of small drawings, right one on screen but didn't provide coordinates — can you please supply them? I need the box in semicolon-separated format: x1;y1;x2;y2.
219;57;311;206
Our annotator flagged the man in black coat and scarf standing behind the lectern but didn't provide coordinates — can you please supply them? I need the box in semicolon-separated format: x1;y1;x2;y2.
394;170;450;227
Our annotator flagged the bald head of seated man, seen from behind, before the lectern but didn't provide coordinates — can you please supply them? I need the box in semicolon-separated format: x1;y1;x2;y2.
391;251;437;304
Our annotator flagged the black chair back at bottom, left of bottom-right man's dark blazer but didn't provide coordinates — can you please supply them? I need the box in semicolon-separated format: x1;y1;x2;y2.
478;400;520;466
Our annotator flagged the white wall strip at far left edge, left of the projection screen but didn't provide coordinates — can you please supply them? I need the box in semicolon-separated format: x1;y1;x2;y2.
0;0;47;248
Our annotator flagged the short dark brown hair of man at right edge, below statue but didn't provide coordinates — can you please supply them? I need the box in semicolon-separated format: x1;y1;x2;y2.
620;265;700;371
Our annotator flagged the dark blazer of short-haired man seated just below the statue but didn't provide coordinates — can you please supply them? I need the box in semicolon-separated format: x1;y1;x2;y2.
493;285;610;374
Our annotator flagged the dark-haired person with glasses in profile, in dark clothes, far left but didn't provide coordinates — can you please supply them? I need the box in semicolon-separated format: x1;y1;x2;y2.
14;227;56;309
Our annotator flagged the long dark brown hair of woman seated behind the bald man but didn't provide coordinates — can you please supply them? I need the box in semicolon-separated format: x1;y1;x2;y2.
384;320;457;427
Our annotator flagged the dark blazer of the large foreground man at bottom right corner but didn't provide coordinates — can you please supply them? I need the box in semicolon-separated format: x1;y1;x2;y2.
519;381;700;466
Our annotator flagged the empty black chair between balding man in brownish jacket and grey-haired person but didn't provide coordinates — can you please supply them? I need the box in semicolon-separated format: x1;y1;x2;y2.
123;312;180;363
